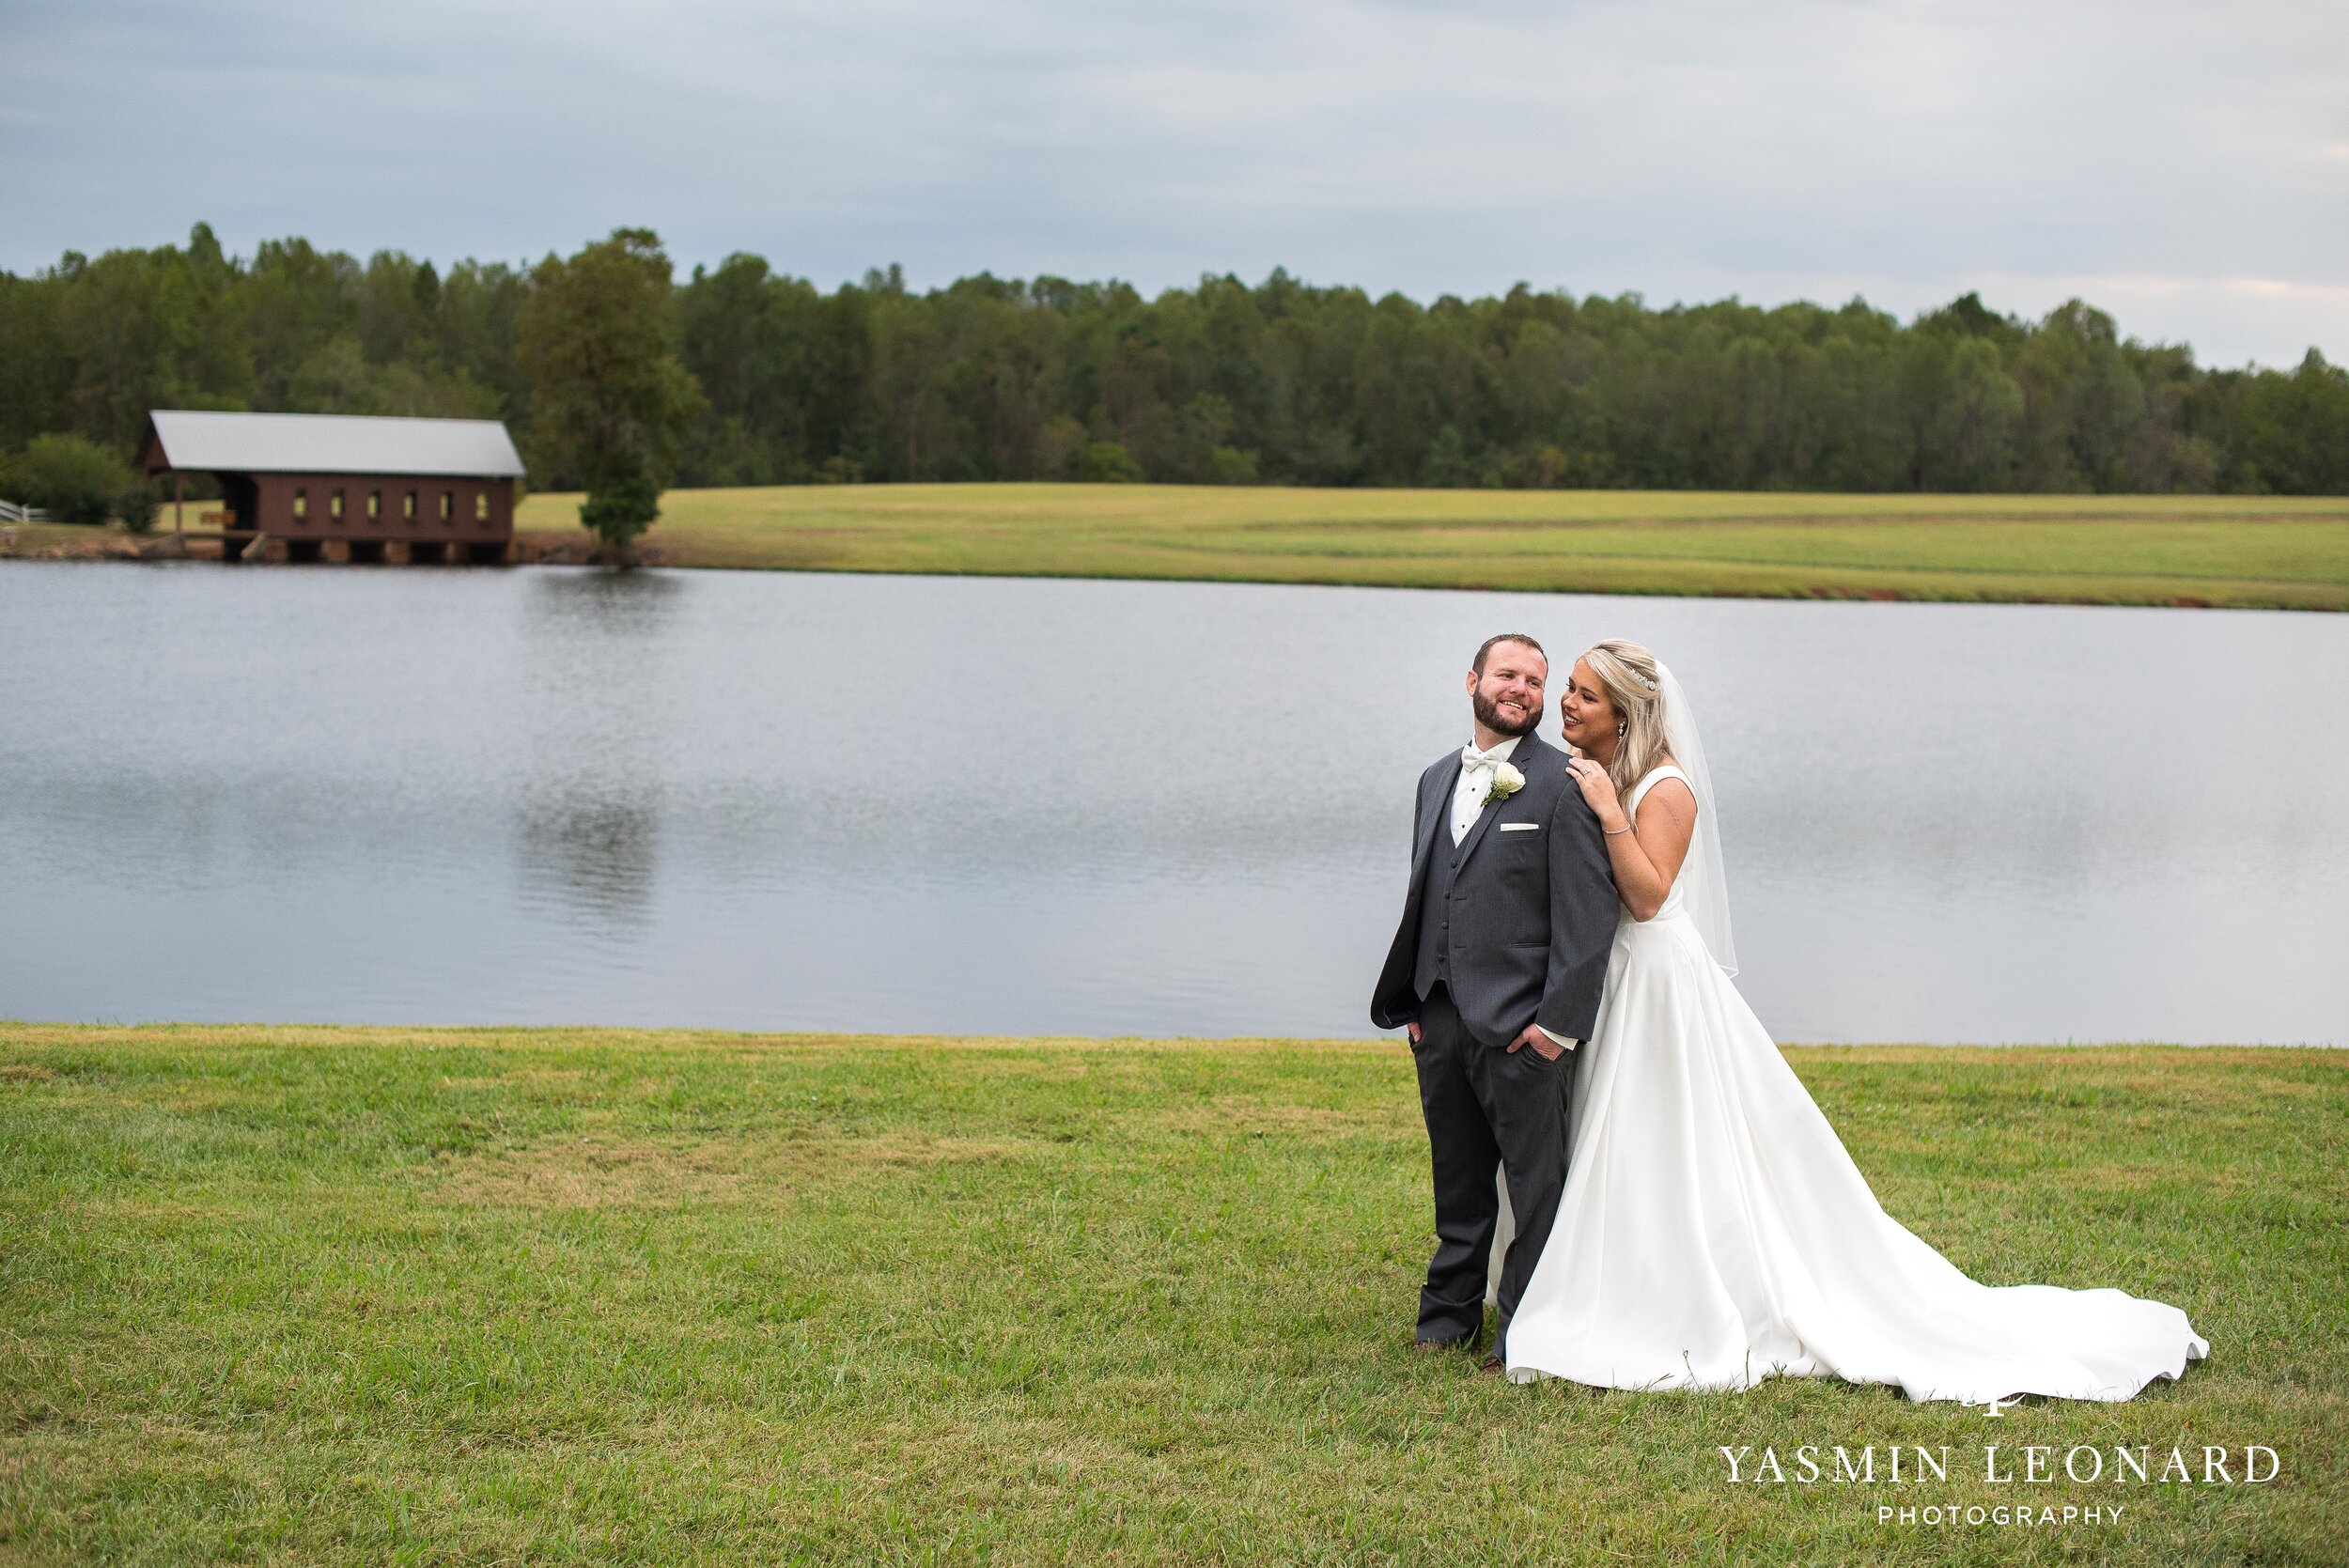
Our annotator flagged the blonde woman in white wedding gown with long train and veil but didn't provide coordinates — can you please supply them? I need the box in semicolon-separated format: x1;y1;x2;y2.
1503;641;2211;1404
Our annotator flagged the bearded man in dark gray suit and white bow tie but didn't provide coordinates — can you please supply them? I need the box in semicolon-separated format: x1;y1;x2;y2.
1370;634;1616;1369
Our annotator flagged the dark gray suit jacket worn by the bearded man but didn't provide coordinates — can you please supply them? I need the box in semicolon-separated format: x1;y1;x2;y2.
1370;735;1621;1049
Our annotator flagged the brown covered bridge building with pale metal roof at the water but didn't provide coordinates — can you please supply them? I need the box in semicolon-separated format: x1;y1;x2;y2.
139;409;524;561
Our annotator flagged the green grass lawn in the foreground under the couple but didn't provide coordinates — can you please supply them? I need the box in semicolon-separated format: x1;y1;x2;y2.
0;1023;2349;1566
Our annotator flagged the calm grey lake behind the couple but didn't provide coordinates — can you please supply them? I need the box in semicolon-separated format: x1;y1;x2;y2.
0;564;2349;1045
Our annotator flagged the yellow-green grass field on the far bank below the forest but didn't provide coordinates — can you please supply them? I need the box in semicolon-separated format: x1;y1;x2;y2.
517;484;2349;611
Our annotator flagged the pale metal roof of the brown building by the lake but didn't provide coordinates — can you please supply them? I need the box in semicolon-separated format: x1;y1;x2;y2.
148;409;524;479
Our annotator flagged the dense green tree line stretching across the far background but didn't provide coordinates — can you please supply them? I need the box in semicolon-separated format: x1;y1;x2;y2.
0;225;2349;509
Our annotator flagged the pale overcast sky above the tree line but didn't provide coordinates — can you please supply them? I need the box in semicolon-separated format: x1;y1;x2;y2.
0;0;2349;364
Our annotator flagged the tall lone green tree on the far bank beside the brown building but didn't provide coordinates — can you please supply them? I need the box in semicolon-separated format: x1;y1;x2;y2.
515;227;705;550
